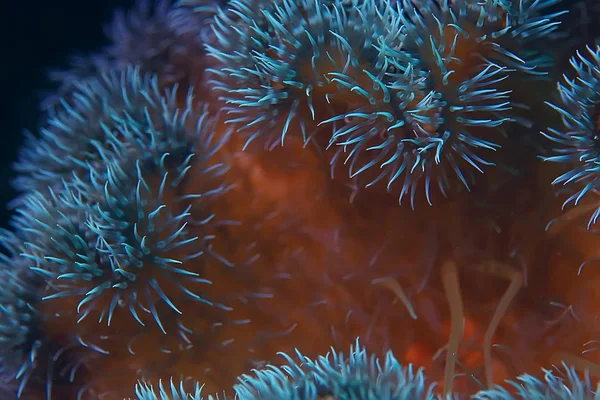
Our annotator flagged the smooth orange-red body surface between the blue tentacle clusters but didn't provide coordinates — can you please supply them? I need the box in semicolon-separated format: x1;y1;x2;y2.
32;89;600;399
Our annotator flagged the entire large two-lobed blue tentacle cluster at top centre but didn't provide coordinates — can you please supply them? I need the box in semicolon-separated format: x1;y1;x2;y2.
209;1;561;206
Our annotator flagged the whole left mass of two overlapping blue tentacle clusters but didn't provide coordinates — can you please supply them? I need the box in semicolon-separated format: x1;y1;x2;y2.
15;64;232;331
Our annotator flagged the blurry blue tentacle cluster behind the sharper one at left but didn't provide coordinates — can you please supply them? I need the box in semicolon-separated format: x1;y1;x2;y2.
15;67;191;202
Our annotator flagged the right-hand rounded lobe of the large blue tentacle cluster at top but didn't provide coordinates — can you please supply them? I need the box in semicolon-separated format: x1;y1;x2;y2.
325;0;562;207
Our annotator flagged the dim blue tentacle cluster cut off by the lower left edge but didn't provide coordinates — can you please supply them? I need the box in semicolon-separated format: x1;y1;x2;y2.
0;230;88;400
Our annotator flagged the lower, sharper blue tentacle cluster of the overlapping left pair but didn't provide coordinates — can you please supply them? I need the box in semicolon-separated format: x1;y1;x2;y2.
19;162;209;330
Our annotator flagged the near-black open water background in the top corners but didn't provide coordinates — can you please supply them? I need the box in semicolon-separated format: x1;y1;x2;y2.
0;0;600;227
